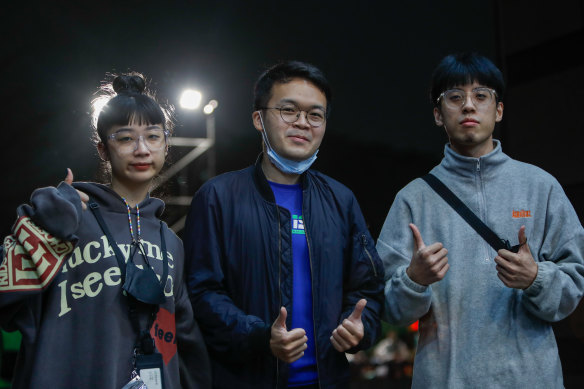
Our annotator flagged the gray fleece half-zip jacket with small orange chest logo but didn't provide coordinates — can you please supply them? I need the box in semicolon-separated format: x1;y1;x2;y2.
377;140;584;389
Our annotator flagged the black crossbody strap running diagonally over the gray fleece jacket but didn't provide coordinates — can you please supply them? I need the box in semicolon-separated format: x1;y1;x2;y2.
422;173;519;252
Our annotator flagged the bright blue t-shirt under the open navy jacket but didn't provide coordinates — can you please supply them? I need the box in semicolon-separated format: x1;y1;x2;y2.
268;181;318;387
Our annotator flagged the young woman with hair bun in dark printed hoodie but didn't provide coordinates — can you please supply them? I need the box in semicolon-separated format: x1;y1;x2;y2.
0;73;211;389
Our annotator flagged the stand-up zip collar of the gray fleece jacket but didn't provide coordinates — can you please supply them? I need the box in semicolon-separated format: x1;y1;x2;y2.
440;139;510;177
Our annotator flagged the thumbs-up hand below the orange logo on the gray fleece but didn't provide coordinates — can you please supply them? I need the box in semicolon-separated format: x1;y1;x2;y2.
495;226;538;289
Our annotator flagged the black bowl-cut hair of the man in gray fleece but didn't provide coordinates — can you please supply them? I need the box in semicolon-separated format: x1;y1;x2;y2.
430;52;505;107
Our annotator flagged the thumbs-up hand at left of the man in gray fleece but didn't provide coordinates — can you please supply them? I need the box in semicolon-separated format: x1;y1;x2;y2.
406;223;450;286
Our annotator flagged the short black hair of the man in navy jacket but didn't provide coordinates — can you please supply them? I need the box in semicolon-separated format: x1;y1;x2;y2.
253;61;332;117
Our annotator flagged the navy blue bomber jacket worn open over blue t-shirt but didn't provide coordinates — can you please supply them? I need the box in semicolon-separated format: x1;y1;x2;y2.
184;157;384;389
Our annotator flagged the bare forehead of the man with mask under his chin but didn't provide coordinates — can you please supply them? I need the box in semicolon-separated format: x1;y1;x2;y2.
269;78;327;108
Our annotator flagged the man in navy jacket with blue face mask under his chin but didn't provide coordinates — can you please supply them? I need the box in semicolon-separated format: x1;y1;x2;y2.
184;61;383;389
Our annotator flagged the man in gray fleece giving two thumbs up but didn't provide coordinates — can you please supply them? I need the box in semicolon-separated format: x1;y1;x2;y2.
377;53;584;389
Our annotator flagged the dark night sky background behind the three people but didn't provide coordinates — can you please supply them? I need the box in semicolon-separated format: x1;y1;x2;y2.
0;0;584;387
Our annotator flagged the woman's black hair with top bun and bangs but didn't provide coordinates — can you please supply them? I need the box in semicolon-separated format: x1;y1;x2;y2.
93;72;174;147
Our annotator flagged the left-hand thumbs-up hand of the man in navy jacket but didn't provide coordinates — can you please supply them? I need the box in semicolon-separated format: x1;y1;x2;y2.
270;307;308;363
